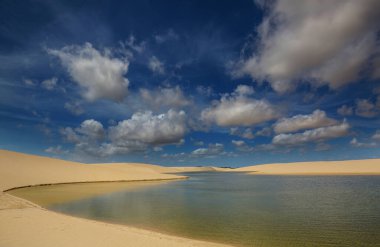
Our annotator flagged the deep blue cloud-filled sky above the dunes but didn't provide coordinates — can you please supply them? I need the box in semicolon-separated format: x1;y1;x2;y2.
0;0;380;167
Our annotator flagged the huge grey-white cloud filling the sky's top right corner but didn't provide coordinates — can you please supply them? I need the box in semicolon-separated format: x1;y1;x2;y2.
233;0;380;93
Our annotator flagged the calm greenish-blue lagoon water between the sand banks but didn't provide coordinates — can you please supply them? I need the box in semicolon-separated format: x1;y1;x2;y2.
12;172;380;247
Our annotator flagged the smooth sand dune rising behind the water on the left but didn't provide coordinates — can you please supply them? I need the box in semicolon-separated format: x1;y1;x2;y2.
0;150;184;191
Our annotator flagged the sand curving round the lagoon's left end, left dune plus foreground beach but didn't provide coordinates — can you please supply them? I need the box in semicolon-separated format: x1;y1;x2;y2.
0;150;229;247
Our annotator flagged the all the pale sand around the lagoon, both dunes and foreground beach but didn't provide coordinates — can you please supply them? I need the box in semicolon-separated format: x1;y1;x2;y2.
0;150;380;247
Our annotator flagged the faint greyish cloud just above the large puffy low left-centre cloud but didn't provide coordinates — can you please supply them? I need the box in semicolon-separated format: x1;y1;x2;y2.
140;86;190;109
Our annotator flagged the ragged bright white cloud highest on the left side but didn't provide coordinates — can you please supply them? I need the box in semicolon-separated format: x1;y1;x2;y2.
48;43;129;101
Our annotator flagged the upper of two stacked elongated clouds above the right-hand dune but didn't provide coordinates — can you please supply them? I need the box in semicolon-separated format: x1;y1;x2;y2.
274;110;337;134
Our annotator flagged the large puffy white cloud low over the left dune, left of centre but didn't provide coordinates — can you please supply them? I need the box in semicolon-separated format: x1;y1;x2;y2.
109;110;187;145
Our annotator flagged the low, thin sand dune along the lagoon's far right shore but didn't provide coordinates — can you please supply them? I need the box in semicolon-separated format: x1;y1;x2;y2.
232;159;380;175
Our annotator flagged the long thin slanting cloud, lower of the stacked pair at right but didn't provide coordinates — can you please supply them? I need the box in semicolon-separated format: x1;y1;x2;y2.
272;121;350;145
